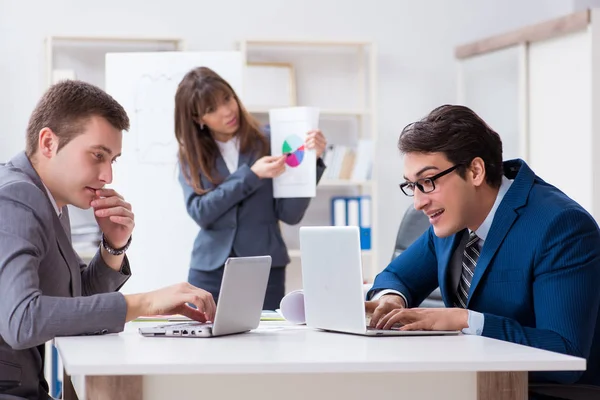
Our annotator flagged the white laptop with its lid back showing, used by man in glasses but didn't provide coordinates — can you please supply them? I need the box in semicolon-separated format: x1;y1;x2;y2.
300;226;460;336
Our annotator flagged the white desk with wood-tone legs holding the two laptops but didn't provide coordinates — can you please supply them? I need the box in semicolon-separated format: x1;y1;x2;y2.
55;322;586;400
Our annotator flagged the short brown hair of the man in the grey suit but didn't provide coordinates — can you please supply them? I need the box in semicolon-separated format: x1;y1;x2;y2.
25;80;129;157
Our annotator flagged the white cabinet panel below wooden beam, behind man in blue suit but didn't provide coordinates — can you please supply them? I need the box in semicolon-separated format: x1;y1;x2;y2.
528;30;599;218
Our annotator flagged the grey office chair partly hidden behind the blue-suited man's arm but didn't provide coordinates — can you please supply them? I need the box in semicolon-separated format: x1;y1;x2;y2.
392;206;445;308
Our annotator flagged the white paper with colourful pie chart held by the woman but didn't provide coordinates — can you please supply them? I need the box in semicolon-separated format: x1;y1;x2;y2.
269;107;319;198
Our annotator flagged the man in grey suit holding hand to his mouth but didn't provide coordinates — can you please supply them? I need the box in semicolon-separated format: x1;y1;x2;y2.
0;81;215;400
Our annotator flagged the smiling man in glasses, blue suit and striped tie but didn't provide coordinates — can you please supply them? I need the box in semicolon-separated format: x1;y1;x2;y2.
367;105;600;385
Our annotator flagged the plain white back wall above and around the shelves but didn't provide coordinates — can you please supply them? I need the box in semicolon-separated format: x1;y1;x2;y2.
0;0;574;272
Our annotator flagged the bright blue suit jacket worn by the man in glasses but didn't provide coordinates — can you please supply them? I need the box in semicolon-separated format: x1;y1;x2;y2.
371;160;600;385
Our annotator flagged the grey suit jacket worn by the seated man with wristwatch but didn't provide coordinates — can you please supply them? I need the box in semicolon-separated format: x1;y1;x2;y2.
0;153;130;400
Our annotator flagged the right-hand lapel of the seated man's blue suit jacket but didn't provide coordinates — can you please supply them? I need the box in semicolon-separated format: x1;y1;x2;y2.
467;160;535;307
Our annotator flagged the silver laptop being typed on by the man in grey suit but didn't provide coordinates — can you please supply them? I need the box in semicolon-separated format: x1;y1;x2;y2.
139;256;271;337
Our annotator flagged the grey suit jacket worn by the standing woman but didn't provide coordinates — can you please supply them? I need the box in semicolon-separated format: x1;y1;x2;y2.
179;142;325;271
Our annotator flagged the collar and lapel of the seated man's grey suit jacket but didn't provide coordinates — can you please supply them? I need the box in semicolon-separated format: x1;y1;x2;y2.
10;152;81;296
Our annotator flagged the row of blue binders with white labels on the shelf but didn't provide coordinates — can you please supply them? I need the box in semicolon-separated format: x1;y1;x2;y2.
331;196;371;250
